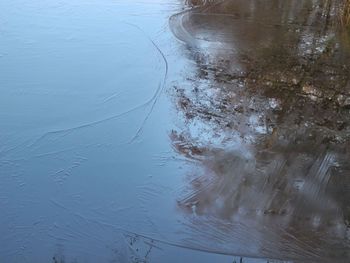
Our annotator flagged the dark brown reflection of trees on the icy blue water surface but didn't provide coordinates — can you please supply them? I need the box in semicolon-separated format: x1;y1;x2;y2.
171;0;350;262
